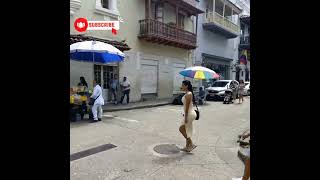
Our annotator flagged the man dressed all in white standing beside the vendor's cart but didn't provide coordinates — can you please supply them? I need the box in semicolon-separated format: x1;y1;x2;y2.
90;80;104;123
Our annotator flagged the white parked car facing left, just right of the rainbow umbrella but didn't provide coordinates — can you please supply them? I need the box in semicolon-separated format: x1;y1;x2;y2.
206;80;239;100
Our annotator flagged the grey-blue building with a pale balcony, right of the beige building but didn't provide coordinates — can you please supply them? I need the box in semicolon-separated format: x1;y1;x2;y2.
195;0;242;84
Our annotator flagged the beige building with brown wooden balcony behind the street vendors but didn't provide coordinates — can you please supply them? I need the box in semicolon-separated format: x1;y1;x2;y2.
70;0;203;102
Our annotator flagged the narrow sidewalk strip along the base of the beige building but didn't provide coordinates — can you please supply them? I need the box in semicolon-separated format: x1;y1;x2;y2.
102;98;172;112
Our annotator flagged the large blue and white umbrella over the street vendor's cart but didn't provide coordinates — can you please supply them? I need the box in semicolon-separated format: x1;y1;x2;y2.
70;41;125;63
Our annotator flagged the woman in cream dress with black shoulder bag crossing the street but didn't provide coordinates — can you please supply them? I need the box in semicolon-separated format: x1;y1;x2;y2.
179;80;197;152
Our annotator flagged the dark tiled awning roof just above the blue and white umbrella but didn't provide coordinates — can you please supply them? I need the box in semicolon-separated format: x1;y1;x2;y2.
70;34;131;51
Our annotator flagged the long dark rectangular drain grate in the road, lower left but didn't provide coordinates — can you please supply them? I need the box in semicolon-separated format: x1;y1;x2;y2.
70;144;117;161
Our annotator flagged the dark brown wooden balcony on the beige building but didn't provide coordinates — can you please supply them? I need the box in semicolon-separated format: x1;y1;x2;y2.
138;19;197;50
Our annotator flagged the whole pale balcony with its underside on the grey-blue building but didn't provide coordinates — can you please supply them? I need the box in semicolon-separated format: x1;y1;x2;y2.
203;12;240;39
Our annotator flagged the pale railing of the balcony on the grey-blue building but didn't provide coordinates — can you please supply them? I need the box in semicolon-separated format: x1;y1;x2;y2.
206;12;240;33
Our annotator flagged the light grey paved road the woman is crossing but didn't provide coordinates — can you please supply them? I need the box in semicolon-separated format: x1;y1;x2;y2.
70;97;250;180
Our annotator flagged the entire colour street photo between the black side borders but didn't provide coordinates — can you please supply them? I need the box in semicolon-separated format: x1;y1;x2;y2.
70;0;251;180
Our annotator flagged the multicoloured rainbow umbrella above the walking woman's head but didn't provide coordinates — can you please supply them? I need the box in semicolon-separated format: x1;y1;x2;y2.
179;66;220;79
